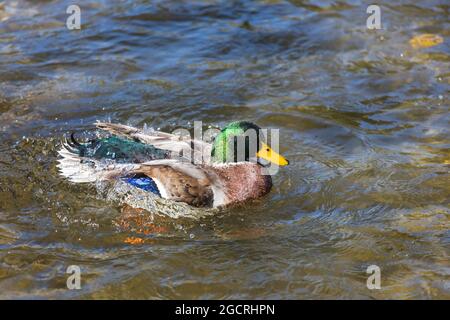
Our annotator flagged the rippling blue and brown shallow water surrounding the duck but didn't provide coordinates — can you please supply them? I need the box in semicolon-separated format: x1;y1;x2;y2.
0;0;450;299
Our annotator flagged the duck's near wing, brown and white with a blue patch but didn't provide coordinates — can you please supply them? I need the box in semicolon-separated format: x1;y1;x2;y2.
58;145;222;207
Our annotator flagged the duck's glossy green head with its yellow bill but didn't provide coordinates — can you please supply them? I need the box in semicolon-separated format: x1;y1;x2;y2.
211;121;289;166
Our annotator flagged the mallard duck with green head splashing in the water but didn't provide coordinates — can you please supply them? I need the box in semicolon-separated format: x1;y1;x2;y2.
58;121;288;208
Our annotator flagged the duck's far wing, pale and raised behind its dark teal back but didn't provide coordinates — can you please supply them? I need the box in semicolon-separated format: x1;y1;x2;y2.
95;122;212;164
